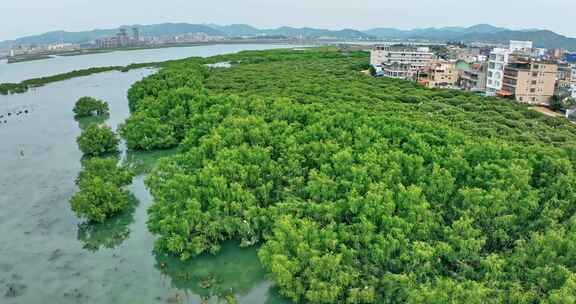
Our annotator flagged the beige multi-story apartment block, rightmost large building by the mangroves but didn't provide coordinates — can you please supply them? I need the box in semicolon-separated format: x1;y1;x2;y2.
498;58;558;105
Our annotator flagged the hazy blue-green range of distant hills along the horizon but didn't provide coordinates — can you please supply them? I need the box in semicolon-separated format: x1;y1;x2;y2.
0;23;576;50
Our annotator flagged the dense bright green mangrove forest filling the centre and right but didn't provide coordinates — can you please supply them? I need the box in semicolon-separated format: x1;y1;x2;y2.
123;50;576;303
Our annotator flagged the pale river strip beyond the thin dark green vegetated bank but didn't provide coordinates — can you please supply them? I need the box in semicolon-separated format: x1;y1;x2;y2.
0;44;291;83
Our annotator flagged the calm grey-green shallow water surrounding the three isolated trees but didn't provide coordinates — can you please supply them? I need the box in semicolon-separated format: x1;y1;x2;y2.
0;45;286;304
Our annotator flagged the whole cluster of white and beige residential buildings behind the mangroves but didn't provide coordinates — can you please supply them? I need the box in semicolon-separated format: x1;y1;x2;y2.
370;41;576;105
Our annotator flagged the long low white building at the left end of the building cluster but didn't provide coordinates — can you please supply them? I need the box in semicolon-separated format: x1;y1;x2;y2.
370;46;434;70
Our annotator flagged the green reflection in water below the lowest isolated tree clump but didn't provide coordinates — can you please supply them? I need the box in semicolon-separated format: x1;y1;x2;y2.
78;193;139;252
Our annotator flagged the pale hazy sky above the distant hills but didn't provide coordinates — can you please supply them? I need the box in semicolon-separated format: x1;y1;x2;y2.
0;0;576;40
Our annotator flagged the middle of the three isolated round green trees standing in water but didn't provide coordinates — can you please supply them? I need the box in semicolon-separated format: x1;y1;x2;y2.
76;124;119;157
